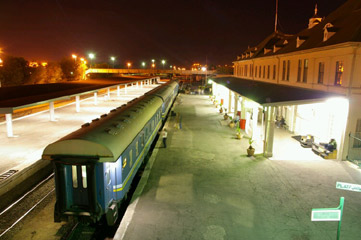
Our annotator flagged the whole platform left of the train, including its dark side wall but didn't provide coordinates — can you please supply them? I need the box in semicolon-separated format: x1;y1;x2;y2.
0;81;159;209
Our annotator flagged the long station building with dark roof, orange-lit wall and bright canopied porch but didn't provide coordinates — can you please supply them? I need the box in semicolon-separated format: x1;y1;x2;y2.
212;0;361;162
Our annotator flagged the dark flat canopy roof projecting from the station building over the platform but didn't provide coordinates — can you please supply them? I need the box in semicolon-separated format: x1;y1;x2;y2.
212;76;345;106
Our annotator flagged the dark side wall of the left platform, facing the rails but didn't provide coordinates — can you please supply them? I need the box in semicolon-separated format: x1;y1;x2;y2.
0;160;53;210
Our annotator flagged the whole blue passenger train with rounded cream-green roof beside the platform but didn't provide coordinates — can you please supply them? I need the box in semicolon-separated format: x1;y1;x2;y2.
42;81;179;226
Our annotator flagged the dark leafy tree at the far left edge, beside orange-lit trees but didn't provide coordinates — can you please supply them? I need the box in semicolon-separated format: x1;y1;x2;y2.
0;56;30;86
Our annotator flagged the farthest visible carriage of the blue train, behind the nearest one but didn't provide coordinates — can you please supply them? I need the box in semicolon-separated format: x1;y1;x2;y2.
146;81;179;120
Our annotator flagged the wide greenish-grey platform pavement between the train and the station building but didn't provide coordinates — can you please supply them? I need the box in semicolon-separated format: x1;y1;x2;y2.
113;94;361;240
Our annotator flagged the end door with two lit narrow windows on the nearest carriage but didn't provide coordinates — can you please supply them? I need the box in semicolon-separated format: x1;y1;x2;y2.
72;165;89;206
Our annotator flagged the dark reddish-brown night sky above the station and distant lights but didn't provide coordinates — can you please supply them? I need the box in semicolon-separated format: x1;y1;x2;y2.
0;0;346;68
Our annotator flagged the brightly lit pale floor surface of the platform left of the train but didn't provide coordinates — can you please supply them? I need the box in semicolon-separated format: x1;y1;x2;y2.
0;85;158;174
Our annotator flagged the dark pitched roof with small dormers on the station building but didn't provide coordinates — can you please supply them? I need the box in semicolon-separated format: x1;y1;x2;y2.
238;0;361;58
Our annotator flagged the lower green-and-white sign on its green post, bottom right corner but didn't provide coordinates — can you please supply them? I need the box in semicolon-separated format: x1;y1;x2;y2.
311;197;345;240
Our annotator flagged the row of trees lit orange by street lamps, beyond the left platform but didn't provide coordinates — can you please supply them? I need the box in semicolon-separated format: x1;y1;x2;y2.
0;56;86;86
